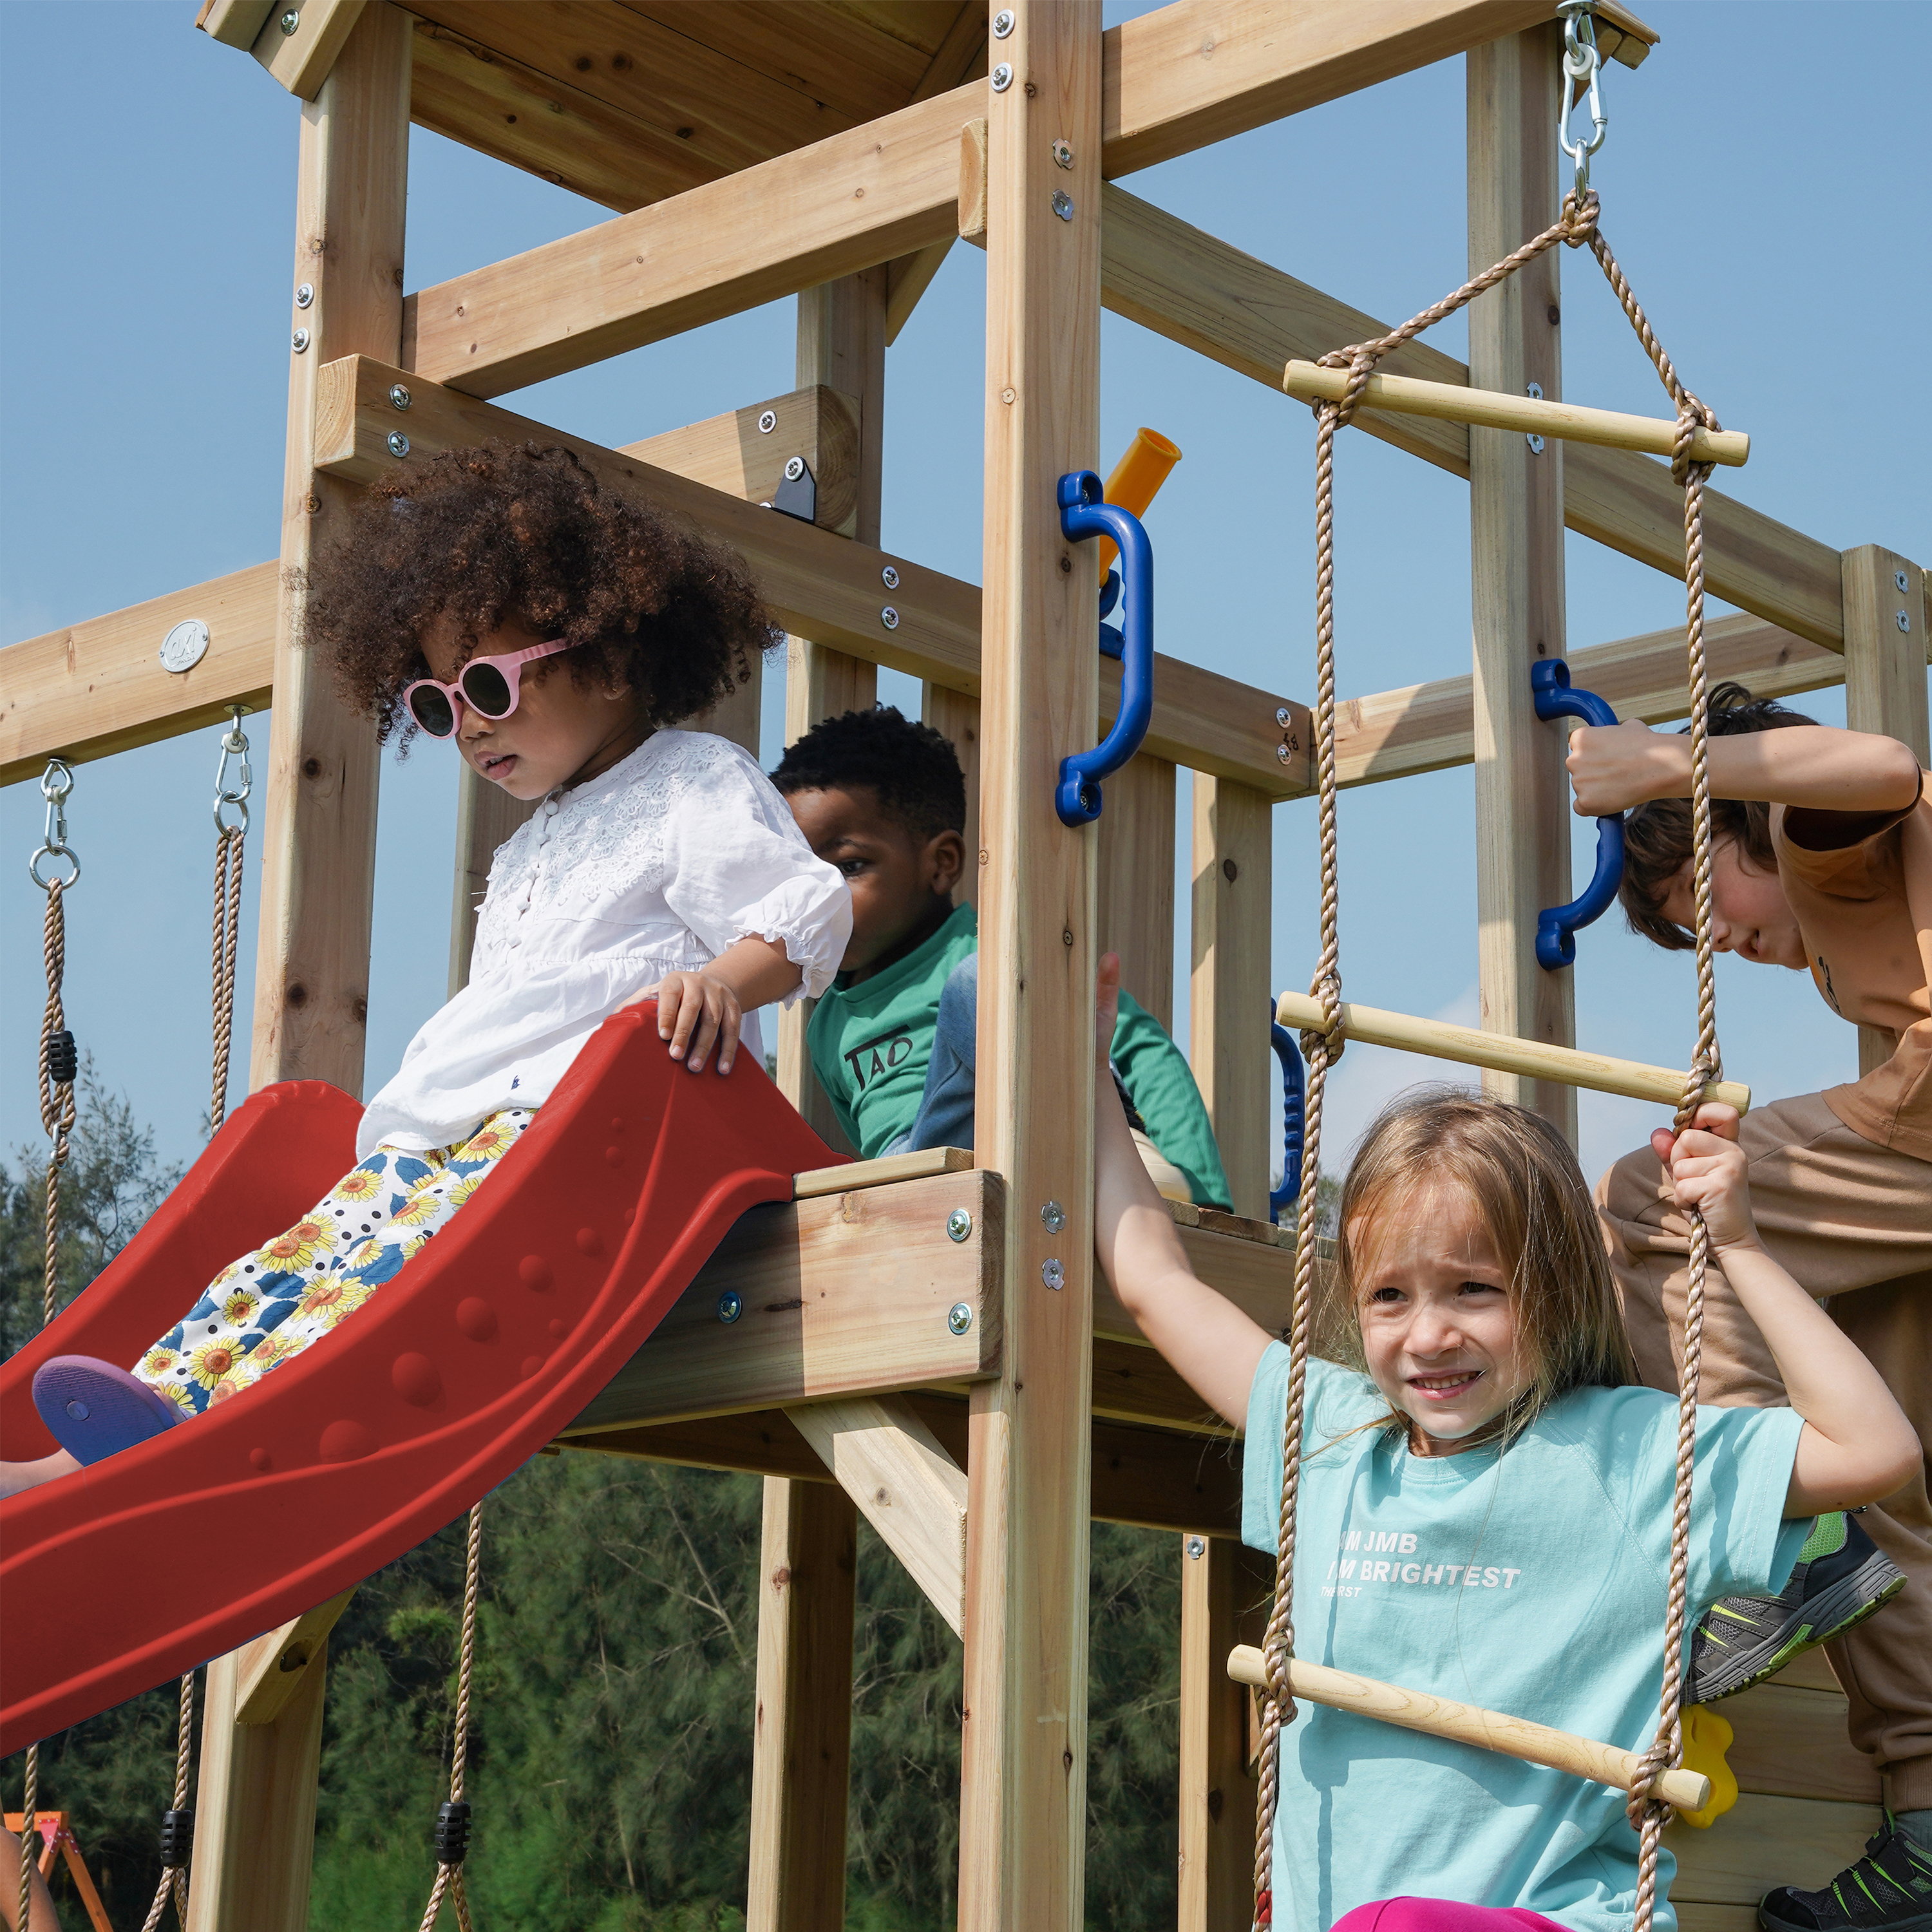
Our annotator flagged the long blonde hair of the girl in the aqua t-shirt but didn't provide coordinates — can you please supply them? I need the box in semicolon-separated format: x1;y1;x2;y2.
1321;1086;1638;1439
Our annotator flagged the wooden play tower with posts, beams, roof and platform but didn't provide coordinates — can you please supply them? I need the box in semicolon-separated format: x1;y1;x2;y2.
0;0;1928;1932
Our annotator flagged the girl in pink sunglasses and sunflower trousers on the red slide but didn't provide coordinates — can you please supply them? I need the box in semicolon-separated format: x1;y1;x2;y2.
13;444;852;1493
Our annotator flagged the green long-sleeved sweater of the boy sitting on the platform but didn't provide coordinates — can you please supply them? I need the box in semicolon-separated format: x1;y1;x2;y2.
806;906;1229;1208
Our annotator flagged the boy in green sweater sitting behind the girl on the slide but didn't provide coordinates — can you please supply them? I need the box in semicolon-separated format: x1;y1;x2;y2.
771;705;1229;1208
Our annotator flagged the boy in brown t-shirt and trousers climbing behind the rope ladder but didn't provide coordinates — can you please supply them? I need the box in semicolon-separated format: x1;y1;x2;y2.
1569;684;1932;1932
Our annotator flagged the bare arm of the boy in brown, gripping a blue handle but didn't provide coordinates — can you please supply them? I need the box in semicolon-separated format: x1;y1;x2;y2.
1569;723;1918;817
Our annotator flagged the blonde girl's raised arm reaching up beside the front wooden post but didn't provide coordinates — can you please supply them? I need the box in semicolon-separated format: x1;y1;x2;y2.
1094;952;1269;1430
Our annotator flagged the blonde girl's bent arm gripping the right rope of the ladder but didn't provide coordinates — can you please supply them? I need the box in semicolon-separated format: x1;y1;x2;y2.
1650;1113;1920;1517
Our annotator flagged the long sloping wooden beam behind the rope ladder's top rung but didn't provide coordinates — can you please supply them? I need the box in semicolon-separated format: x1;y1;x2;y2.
1101;182;1843;649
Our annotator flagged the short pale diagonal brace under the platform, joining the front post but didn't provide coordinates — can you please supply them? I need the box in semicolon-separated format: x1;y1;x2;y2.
786;1397;966;1638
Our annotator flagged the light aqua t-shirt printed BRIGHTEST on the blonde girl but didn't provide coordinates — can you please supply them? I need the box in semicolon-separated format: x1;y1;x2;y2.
1242;1343;1812;1932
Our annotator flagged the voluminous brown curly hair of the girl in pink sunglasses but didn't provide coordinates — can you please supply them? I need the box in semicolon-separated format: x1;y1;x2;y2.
305;442;779;744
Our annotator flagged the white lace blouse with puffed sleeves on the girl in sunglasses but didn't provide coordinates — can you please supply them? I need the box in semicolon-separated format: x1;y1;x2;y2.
355;730;852;1159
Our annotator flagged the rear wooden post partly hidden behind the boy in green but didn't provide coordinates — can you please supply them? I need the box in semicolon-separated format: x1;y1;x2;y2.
746;265;887;1932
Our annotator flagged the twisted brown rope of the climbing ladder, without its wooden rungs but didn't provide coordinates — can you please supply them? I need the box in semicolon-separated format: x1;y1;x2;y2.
1254;192;1721;1932
